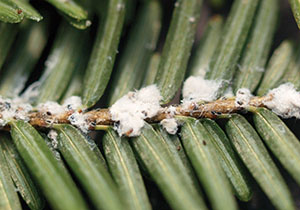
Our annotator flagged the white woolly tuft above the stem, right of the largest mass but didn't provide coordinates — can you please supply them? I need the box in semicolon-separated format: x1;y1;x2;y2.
182;76;222;103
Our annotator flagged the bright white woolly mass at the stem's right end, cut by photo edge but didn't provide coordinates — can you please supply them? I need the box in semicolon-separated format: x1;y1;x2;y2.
264;83;300;118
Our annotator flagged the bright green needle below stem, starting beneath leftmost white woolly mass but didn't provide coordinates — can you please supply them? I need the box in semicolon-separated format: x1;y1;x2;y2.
10;121;87;210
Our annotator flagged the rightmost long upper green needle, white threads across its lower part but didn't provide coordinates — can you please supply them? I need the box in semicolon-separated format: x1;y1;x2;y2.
233;0;279;93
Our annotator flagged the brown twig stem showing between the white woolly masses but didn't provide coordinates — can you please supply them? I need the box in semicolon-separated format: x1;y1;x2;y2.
14;96;271;130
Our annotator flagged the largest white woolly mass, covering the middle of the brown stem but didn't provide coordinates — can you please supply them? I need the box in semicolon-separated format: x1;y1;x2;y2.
109;85;162;136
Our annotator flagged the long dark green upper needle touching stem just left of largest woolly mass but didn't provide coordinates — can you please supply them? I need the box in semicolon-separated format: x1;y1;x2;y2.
82;0;125;108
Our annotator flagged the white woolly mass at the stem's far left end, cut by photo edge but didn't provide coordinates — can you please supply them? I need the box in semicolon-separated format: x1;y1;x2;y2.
0;96;32;127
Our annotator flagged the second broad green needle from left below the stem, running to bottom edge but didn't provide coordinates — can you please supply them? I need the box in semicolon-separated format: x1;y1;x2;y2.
55;125;122;209
